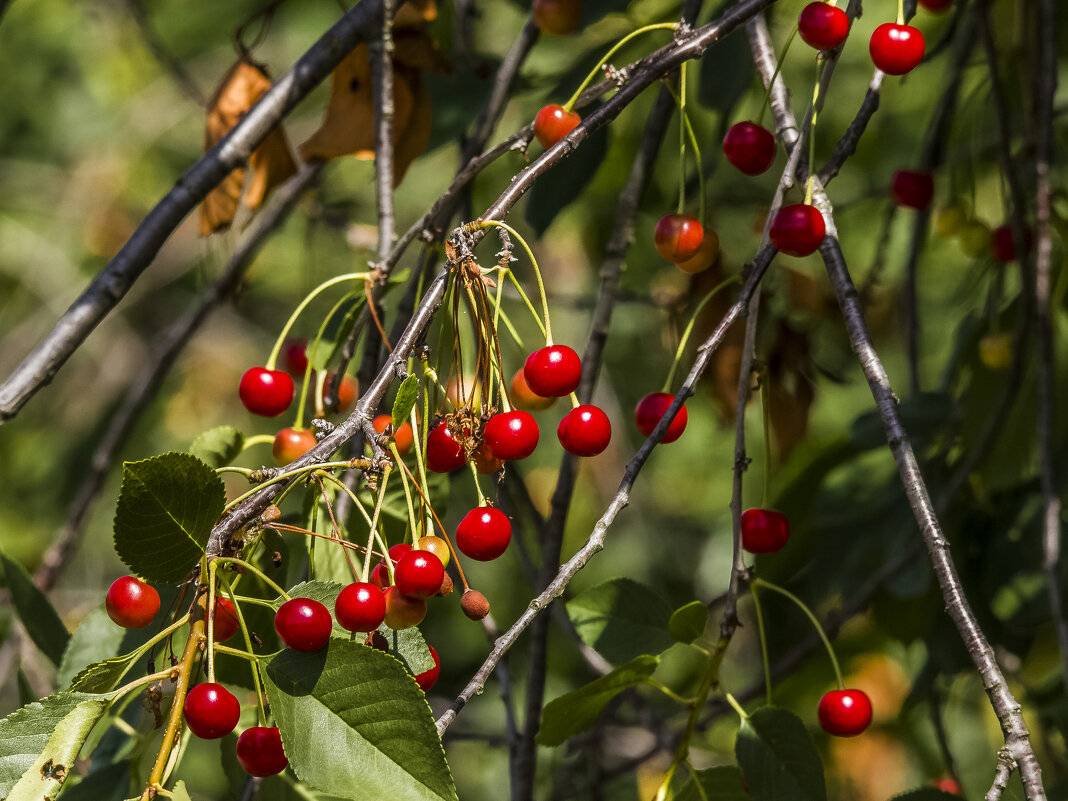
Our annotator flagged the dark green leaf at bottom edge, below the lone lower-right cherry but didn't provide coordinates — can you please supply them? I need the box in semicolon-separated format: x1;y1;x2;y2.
735;707;827;801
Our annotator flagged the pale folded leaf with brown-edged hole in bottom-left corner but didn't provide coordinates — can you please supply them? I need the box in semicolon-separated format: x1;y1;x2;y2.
0;692;110;801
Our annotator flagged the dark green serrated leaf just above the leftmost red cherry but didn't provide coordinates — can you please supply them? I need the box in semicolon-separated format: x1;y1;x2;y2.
114;453;226;584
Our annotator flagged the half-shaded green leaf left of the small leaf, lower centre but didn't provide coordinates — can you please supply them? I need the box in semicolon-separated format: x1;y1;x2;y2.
567;579;675;664
